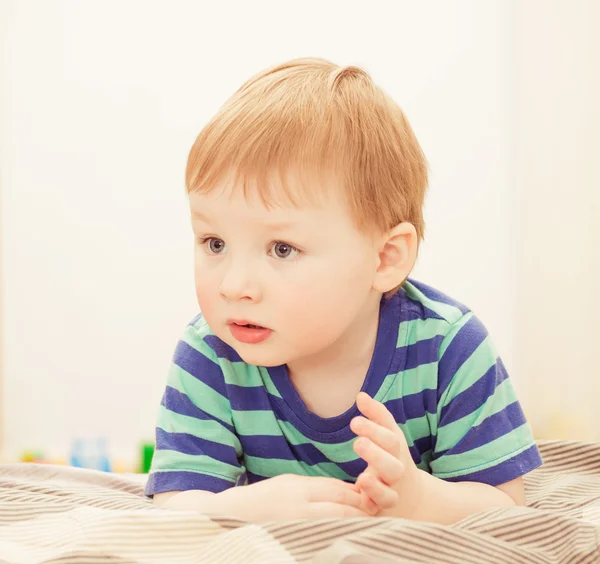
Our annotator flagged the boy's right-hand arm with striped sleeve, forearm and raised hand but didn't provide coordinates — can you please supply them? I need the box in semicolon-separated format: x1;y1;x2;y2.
353;312;542;521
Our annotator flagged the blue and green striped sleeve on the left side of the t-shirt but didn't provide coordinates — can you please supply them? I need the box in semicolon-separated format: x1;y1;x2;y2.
145;322;244;496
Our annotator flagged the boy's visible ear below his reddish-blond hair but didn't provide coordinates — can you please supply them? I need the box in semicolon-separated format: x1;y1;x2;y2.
373;222;419;294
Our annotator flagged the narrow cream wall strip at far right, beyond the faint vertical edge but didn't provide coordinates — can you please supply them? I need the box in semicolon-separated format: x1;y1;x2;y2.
515;0;600;441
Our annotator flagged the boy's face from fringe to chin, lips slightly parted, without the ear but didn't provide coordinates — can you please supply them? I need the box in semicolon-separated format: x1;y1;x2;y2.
189;177;381;366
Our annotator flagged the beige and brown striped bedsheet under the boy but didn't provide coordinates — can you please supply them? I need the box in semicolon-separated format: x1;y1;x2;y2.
0;441;600;564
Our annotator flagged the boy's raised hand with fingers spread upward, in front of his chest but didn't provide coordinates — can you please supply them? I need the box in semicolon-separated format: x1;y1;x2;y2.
350;392;423;517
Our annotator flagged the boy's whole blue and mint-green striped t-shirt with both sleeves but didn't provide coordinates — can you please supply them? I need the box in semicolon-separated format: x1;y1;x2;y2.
146;280;542;495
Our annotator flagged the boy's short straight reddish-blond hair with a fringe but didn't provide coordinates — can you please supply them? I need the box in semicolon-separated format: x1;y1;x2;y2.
185;58;427;241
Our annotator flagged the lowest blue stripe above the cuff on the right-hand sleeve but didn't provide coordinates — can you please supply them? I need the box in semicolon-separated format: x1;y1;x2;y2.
435;401;526;458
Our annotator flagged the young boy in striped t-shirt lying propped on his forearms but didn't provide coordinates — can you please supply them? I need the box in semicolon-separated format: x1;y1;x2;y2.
146;59;542;523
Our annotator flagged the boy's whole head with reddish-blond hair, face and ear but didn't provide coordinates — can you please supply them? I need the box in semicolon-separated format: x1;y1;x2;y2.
186;59;427;365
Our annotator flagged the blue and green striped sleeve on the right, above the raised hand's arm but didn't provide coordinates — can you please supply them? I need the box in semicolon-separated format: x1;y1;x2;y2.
430;312;542;486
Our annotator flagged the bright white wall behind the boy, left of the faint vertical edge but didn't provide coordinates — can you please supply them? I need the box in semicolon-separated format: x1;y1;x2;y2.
0;0;518;462
